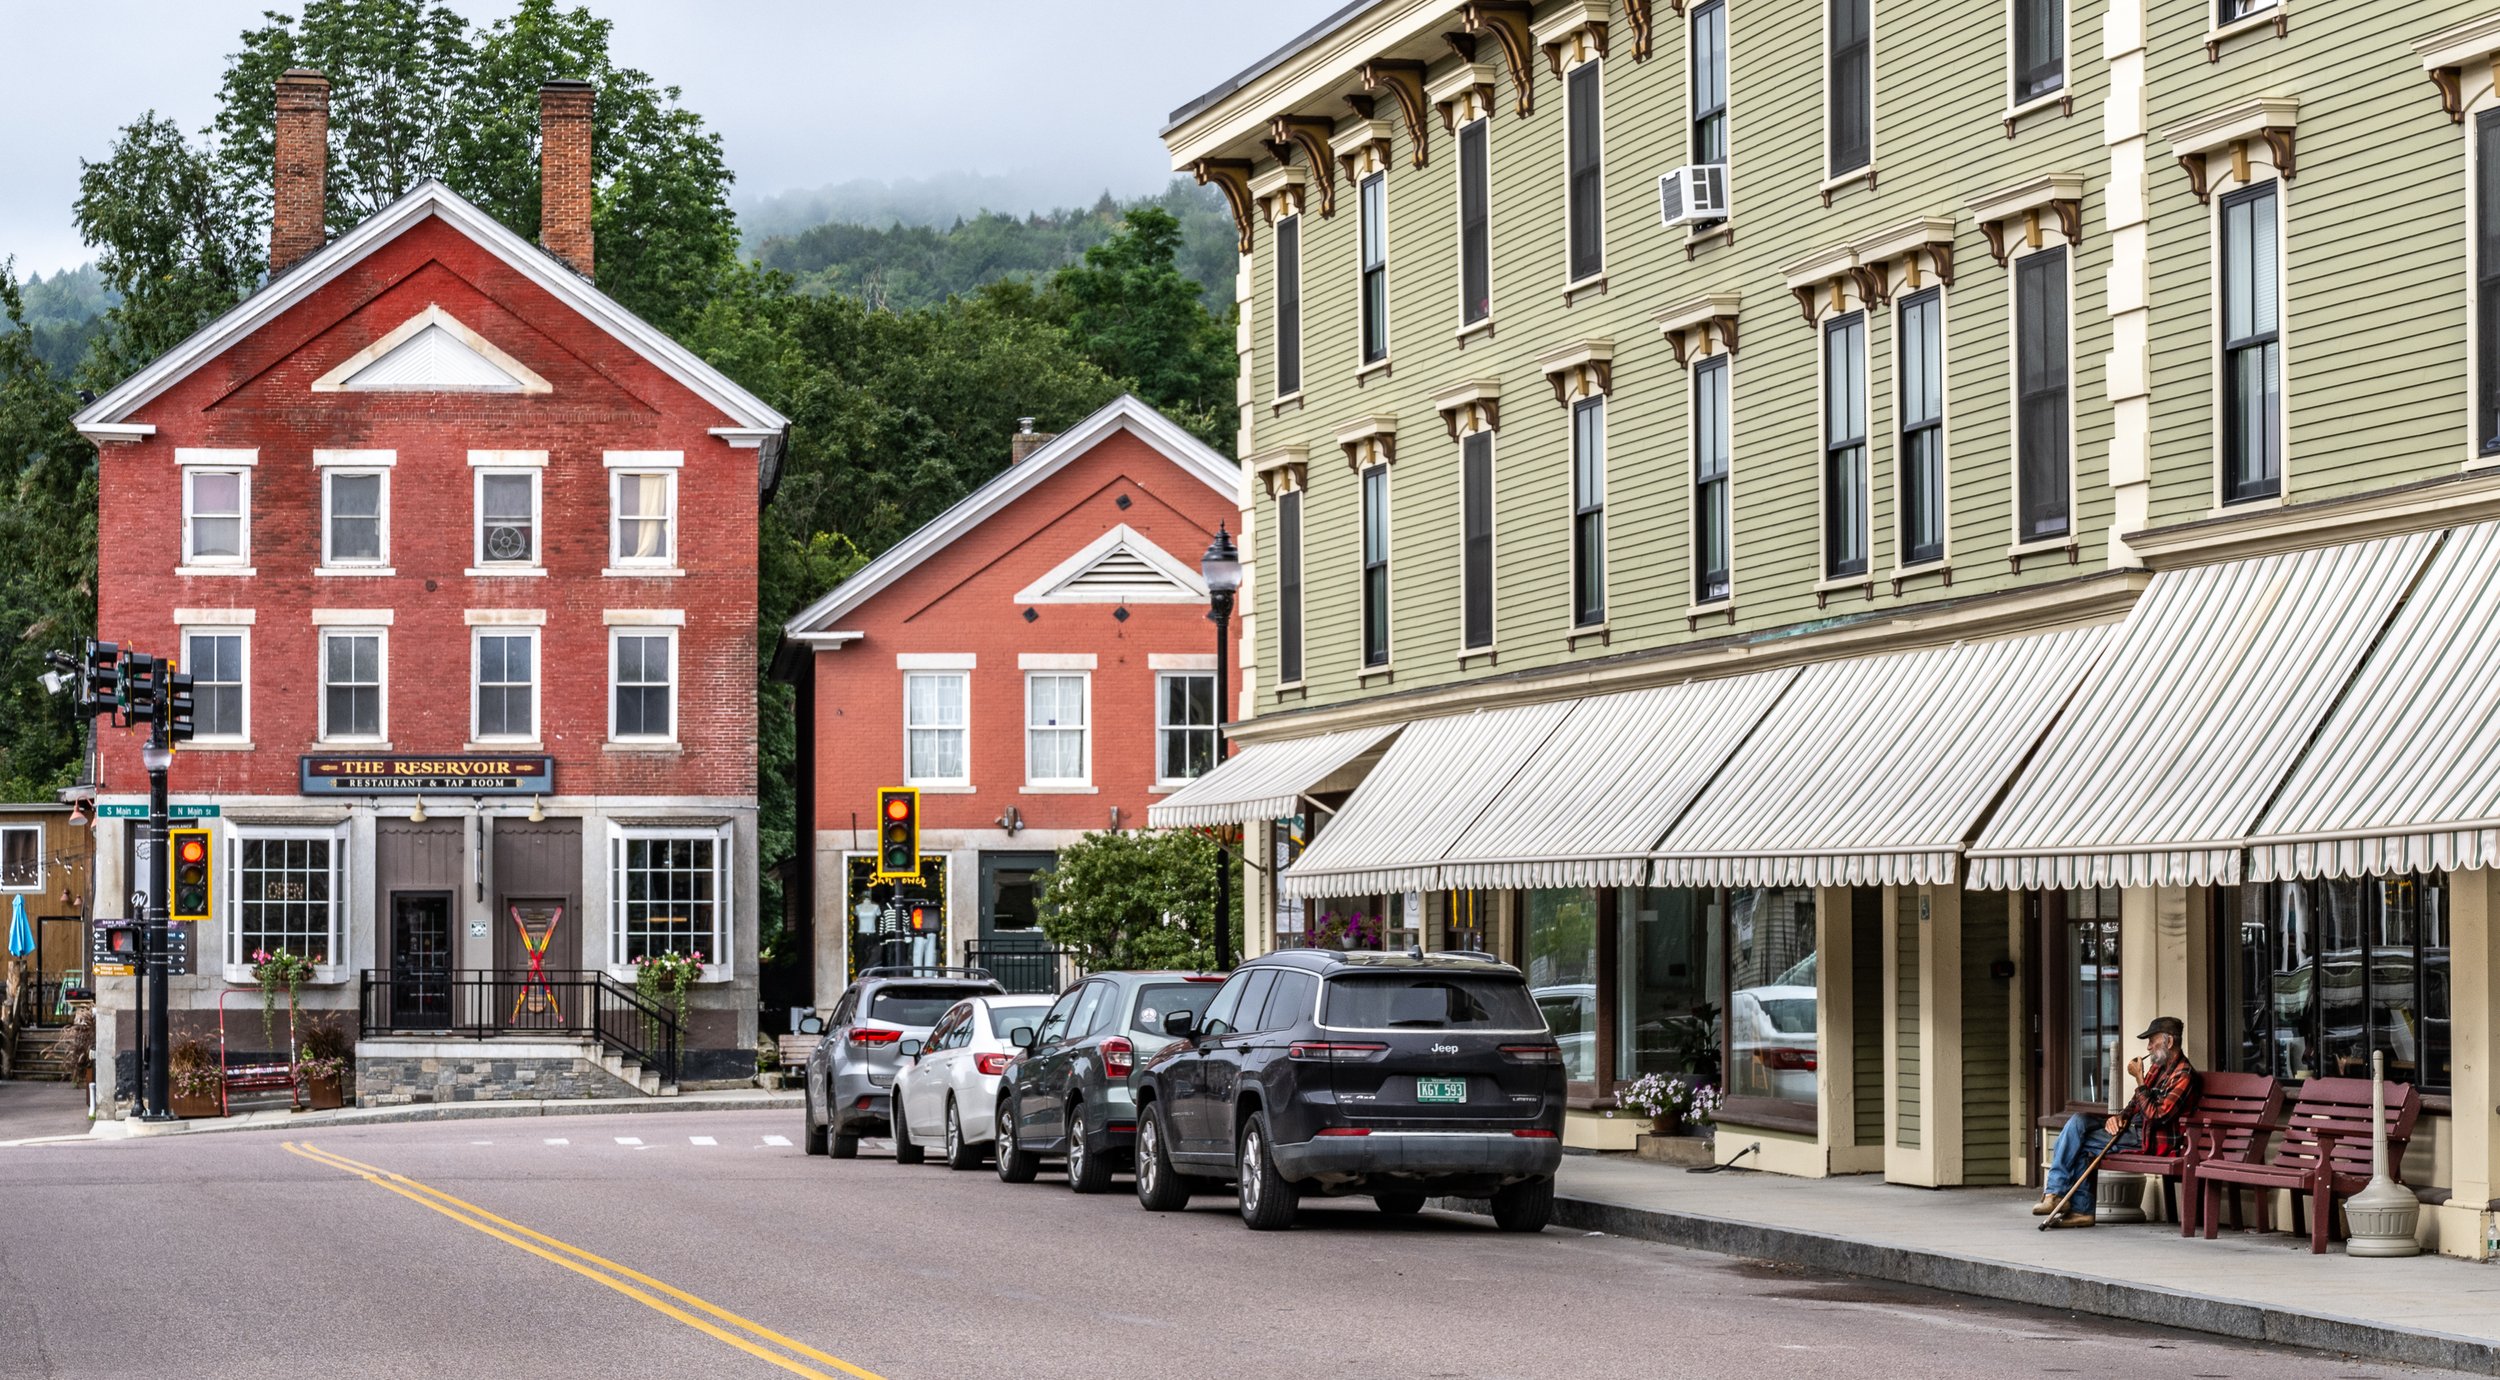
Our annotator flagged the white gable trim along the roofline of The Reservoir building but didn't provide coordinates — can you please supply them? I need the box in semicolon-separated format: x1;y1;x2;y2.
78;178;790;443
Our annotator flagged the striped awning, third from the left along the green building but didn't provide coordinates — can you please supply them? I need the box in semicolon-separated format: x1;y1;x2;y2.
1438;668;1798;890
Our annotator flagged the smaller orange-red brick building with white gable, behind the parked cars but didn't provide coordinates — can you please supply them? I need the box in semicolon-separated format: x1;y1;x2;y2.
775;398;1240;1010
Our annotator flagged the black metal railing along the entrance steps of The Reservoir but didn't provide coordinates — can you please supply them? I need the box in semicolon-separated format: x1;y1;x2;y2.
358;968;685;1083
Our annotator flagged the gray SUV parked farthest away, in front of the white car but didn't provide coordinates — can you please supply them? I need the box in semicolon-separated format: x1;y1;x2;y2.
808;968;1005;1160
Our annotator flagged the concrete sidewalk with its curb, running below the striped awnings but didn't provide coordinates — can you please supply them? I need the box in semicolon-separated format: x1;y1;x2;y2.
1463;1155;2500;1375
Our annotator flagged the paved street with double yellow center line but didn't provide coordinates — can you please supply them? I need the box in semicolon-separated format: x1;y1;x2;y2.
0;1113;2460;1380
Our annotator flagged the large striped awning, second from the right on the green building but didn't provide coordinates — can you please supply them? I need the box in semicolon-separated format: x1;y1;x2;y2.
1968;533;2438;888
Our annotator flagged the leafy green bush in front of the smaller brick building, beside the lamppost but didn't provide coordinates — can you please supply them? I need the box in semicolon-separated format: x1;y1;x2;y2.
1038;830;1240;970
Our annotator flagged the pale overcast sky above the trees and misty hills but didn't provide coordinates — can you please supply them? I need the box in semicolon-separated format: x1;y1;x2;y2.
0;0;1338;278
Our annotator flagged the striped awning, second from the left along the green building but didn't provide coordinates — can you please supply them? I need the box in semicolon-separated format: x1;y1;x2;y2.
1280;700;1573;898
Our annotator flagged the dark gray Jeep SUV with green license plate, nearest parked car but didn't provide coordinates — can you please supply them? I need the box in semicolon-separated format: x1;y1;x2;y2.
1135;950;1565;1233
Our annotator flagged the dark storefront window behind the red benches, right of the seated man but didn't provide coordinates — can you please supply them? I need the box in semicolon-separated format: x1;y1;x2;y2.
2218;875;2450;1088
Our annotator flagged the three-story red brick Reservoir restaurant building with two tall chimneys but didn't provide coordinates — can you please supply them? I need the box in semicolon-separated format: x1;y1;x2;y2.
80;73;788;1100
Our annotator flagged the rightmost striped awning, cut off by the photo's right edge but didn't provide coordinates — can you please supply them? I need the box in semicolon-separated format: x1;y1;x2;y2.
2248;523;2500;883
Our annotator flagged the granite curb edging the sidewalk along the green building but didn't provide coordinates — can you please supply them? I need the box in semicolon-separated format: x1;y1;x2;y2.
1435;1195;2500;1375
